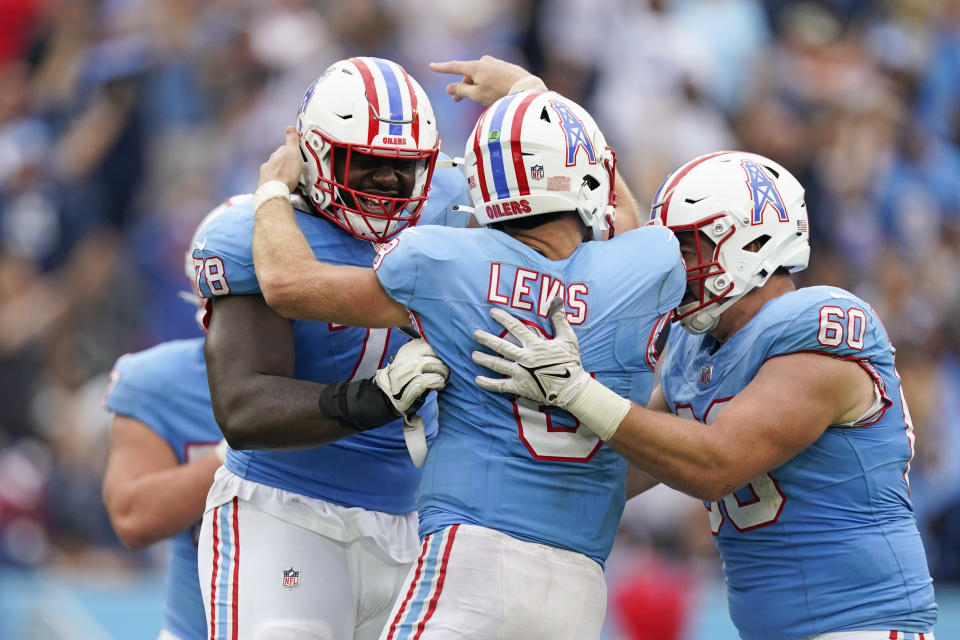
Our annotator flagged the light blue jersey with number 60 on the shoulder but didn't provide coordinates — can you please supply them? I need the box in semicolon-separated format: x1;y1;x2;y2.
660;287;937;640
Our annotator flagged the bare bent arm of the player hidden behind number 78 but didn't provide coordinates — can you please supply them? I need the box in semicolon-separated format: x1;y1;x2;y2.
103;414;221;549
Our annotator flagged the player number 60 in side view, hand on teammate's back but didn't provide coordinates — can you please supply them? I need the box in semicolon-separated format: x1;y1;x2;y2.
475;152;937;640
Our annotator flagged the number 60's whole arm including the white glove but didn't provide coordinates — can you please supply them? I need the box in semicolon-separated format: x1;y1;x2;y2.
474;304;873;500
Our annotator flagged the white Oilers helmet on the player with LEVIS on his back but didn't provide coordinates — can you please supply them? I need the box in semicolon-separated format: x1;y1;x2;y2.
464;91;616;239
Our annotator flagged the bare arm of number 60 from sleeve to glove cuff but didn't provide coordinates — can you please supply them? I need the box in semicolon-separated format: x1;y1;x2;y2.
607;353;871;500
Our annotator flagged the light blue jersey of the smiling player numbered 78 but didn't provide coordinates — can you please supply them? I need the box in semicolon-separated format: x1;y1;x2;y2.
193;160;467;514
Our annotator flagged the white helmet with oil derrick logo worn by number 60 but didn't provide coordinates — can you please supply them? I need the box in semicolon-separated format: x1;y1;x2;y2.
650;151;810;333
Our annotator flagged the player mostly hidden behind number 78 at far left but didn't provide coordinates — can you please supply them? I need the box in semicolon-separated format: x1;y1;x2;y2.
103;207;232;640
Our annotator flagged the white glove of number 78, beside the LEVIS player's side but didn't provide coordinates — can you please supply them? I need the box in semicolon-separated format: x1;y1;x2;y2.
373;338;450;467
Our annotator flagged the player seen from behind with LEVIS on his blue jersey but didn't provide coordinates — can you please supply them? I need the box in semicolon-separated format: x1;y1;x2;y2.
254;77;684;640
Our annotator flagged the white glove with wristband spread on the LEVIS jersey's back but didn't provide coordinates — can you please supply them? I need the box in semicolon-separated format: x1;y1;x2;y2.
473;298;630;441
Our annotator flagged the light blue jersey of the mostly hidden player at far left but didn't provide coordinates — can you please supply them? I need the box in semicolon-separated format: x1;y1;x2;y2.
106;338;223;640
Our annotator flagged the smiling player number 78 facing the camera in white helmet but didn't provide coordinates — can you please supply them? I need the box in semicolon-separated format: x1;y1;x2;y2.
193;58;468;640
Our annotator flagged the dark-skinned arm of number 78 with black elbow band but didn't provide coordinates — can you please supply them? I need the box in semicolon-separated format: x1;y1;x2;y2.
204;295;399;449
